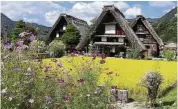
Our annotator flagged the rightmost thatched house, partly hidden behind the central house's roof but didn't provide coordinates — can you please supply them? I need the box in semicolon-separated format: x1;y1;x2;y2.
131;15;164;57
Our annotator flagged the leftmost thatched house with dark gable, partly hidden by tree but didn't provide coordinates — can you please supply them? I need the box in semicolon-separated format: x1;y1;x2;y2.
47;13;89;43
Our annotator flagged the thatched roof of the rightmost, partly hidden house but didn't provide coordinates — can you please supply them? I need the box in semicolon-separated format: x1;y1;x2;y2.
130;15;164;46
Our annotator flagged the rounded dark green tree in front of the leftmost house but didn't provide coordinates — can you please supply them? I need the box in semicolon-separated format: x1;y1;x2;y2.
61;24;80;48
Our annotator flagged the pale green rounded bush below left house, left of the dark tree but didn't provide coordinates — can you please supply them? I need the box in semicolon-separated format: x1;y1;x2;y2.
48;40;65;58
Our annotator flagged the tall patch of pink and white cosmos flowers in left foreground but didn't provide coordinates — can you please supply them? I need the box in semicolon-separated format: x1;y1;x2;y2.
1;33;116;109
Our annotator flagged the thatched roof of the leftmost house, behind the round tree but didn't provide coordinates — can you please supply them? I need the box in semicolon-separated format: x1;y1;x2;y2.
47;13;89;43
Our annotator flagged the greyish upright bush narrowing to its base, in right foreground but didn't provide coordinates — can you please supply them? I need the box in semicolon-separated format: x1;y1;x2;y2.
141;72;163;107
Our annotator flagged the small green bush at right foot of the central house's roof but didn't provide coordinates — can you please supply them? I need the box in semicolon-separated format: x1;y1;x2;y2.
128;49;140;59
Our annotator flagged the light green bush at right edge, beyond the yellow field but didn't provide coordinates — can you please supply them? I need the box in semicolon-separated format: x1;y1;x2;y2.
163;50;176;61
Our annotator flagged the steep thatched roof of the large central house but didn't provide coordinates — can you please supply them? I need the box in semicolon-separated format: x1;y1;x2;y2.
76;5;146;50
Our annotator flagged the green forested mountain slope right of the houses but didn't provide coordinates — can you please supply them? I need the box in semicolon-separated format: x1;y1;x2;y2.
153;7;177;42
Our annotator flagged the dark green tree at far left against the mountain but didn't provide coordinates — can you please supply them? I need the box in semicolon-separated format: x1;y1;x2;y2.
11;20;25;42
